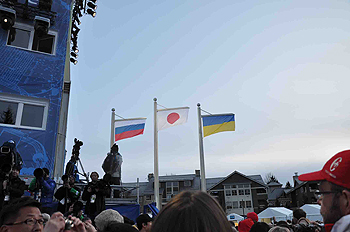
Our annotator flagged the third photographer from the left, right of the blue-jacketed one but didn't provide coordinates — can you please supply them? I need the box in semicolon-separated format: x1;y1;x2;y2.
55;175;80;214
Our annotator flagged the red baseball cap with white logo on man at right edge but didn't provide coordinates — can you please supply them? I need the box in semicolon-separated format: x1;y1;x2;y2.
299;150;350;189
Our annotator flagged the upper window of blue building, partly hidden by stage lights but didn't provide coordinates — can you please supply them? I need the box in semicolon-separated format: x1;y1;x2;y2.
7;23;57;54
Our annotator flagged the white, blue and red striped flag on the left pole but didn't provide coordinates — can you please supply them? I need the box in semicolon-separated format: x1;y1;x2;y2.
114;118;146;141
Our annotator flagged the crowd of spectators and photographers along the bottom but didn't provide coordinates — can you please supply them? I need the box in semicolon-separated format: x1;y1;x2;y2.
0;145;350;232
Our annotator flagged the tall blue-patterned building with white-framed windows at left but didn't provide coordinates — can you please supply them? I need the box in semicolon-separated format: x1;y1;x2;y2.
0;0;72;179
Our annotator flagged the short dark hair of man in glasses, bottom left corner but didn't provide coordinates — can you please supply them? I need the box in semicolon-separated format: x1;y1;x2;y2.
0;197;41;226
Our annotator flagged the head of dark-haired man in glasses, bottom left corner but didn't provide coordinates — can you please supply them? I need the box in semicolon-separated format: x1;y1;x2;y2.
0;197;44;232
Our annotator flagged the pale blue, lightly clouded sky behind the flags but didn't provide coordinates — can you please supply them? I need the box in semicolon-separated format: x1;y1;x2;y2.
66;0;350;185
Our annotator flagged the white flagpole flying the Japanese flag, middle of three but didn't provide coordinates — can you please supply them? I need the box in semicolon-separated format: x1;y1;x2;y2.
153;98;162;210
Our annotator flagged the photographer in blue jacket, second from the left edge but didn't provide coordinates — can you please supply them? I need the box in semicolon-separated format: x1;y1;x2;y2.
28;168;56;215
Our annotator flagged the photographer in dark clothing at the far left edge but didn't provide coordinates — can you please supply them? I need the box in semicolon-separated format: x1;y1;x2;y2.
0;166;26;209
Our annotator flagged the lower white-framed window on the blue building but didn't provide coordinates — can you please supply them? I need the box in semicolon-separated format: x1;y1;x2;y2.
0;95;49;130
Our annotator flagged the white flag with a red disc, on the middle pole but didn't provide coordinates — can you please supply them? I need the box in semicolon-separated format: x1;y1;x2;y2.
157;107;190;131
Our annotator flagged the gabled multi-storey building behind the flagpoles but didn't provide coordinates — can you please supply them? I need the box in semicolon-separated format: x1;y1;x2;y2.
123;170;267;215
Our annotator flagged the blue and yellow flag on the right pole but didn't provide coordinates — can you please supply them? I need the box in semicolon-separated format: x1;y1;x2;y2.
202;114;235;137
